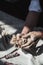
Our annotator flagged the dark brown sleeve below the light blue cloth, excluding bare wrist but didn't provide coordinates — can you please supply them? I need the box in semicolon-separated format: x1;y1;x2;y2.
25;11;39;28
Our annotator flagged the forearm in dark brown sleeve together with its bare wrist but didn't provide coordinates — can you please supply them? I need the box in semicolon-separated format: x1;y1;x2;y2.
22;11;39;34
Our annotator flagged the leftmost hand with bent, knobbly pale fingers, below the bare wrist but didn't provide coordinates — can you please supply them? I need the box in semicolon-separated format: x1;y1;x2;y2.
10;33;23;45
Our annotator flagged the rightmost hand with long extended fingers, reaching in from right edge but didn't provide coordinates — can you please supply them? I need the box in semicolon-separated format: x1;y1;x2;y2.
21;31;41;49
